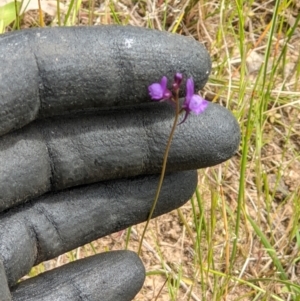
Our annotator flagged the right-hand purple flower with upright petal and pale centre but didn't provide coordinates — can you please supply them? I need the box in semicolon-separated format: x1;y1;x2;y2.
181;78;208;123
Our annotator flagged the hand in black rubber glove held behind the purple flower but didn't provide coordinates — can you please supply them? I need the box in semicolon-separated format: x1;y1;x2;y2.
0;26;240;301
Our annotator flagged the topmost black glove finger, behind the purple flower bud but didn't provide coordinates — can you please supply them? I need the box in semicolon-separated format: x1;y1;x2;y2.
0;26;211;135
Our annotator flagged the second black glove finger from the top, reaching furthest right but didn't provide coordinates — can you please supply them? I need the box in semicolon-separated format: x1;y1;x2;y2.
0;103;240;211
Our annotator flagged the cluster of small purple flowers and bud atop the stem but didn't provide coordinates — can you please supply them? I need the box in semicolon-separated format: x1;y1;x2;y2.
148;73;208;123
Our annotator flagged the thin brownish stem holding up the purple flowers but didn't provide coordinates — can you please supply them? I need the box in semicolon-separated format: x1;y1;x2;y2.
138;91;180;256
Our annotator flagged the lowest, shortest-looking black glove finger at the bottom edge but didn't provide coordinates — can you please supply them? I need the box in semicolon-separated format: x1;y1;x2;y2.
12;251;145;301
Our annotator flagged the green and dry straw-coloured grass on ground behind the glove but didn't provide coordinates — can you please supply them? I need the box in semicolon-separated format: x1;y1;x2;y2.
0;0;300;301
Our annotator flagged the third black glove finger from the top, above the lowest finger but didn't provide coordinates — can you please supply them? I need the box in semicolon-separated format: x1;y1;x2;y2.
0;171;197;286
